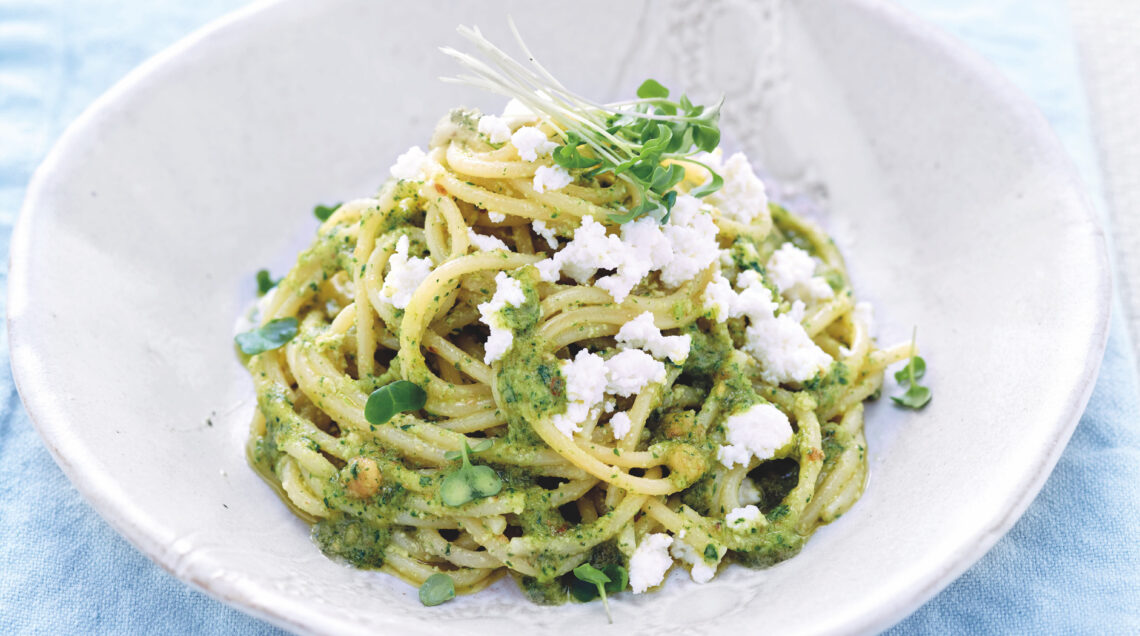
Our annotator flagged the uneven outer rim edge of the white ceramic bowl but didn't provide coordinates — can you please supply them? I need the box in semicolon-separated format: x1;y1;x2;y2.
7;0;1113;633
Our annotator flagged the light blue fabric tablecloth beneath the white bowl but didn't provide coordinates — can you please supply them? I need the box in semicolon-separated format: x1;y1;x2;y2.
0;0;1140;634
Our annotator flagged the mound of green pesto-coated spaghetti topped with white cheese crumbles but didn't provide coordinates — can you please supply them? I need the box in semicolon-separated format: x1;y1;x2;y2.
238;26;912;615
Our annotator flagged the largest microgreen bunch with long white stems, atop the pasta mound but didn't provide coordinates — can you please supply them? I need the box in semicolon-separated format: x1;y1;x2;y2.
441;21;724;223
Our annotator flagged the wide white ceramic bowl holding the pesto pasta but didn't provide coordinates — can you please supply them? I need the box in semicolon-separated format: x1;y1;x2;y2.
8;0;1109;634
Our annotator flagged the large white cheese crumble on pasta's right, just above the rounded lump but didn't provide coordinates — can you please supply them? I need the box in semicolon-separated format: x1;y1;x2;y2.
743;313;831;384
